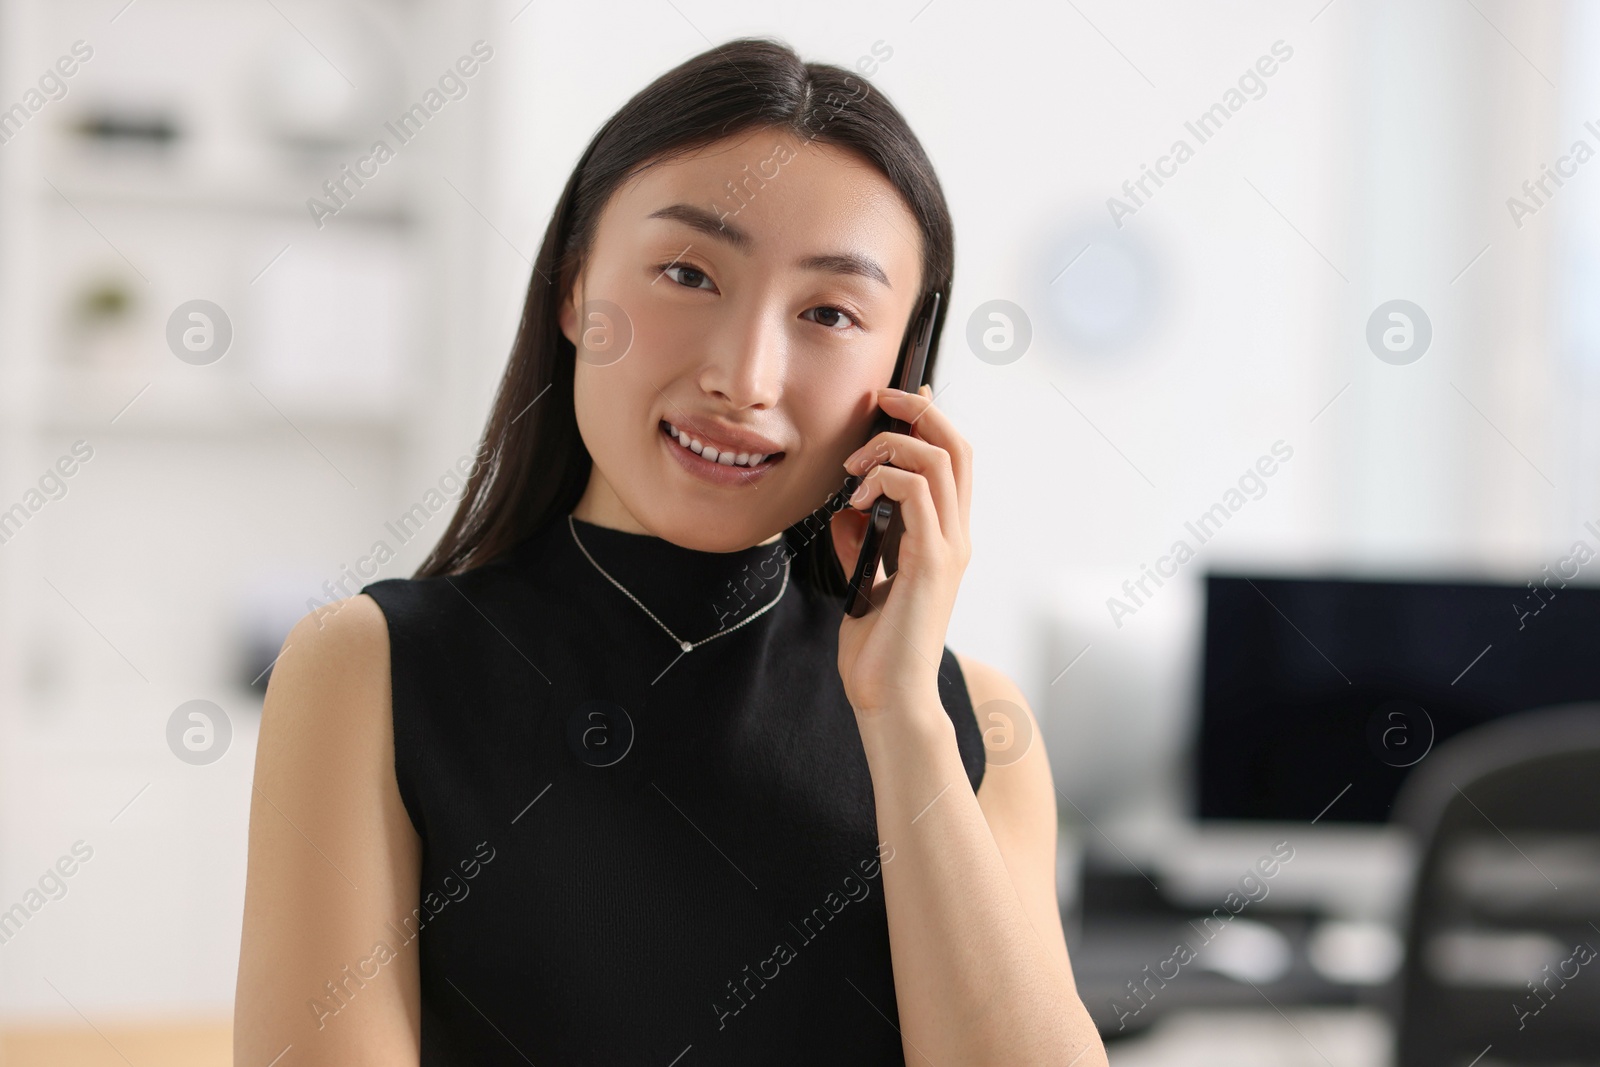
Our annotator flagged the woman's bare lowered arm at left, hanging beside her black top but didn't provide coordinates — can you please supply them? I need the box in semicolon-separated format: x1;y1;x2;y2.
234;597;421;1067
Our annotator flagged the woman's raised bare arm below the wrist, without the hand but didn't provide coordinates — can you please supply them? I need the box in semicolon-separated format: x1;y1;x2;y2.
862;659;1106;1067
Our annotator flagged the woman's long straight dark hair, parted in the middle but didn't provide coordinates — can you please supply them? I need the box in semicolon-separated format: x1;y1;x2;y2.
416;38;955;597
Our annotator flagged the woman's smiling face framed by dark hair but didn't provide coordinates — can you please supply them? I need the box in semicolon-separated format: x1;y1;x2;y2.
562;130;922;552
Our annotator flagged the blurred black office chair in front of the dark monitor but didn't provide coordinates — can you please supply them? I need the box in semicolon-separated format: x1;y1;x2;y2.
1392;702;1600;1067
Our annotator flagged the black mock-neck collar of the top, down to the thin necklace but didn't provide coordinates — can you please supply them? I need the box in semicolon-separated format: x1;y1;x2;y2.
550;515;795;641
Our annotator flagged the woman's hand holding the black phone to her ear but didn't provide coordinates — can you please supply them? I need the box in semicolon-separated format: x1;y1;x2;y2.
832;386;973;715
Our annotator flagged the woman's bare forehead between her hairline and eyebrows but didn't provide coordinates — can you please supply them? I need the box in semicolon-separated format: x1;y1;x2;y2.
602;128;922;294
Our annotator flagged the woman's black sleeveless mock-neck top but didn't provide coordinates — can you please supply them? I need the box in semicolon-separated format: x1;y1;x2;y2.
363;517;984;1067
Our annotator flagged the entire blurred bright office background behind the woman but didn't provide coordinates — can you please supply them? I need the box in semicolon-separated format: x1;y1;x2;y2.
0;0;1600;1067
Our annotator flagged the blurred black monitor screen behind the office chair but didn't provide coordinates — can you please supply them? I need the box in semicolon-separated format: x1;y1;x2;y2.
1198;572;1600;822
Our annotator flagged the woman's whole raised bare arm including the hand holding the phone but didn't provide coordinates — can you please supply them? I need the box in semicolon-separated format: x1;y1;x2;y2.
832;386;1106;1067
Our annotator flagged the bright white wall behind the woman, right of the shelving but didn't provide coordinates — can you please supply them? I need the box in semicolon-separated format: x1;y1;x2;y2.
490;0;1568;817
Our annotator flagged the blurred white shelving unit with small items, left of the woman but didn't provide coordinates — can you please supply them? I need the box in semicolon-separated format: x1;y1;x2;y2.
0;0;498;1021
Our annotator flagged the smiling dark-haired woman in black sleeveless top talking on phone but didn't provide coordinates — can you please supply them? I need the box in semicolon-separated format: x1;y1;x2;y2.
235;40;1104;1067
